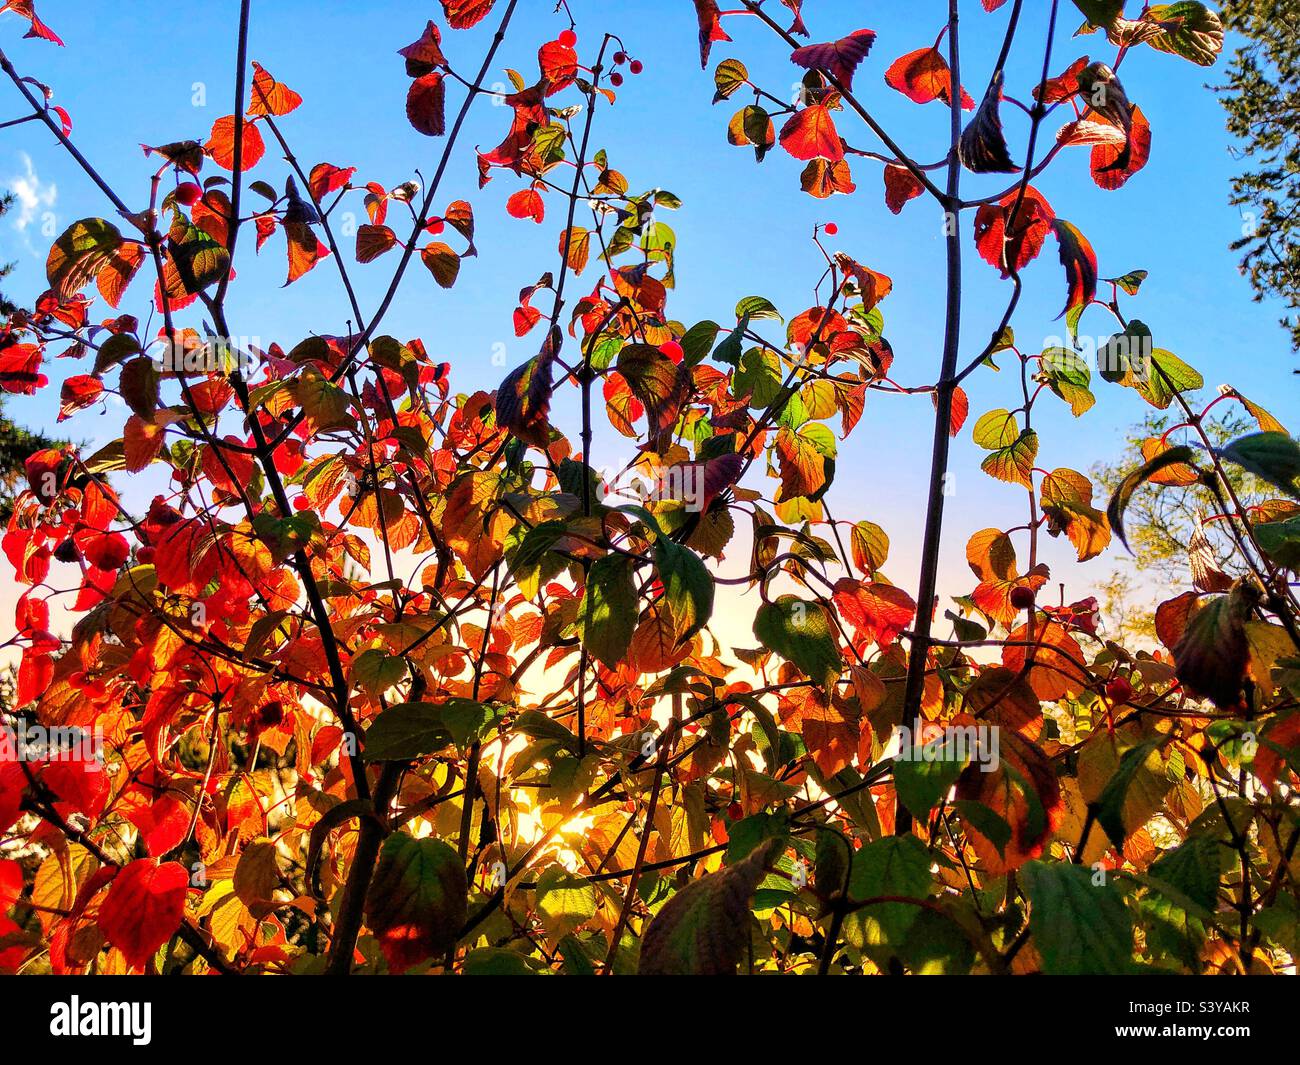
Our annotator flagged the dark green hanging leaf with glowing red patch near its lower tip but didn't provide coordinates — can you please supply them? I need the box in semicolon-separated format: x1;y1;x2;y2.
365;831;469;973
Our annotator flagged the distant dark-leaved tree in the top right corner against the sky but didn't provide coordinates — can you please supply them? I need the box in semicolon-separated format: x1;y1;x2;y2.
1218;0;1300;348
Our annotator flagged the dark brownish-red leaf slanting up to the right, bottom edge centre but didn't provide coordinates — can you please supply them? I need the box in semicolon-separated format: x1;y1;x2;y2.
637;840;783;977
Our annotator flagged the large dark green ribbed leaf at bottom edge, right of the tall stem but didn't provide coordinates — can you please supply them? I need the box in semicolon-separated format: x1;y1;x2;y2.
1021;861;1134;975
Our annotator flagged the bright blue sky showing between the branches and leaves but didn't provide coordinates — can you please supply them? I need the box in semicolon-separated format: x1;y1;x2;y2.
0;0;1300;616
